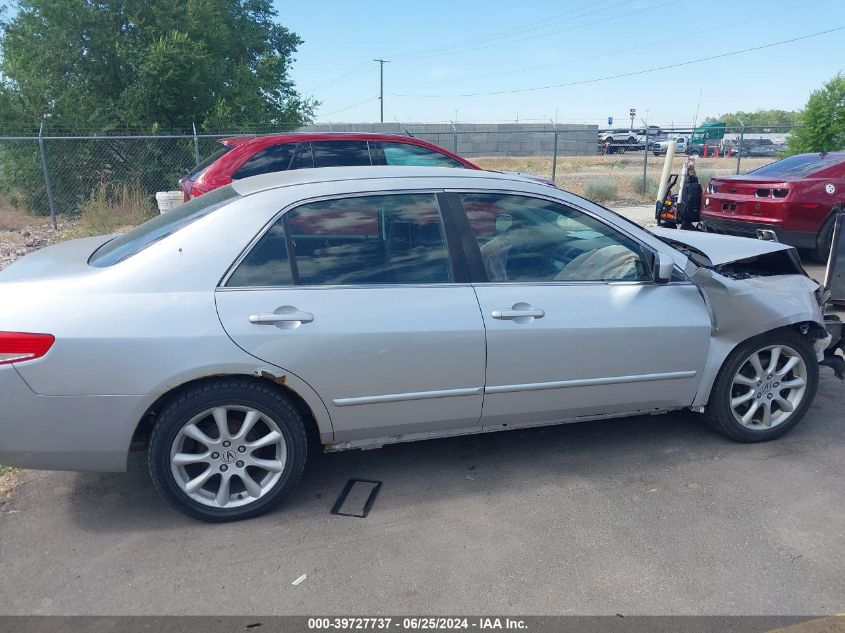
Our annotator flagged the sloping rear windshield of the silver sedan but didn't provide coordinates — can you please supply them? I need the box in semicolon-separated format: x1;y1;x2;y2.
88;185;240;268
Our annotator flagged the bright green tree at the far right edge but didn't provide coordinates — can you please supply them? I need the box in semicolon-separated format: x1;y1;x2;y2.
787;73;845;154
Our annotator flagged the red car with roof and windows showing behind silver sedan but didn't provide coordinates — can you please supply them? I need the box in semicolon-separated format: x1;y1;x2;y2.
179;133;480;202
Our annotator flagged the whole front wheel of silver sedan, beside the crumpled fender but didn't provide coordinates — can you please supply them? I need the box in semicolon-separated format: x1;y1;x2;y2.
704;329;819;442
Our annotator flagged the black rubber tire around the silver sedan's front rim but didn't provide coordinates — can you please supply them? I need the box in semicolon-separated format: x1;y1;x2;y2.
704;328;819;443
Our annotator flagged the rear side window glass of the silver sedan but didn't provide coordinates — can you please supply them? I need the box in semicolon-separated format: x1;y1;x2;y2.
226;194;453;287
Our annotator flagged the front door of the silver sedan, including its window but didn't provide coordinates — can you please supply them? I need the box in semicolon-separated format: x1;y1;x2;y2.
448;193;711;424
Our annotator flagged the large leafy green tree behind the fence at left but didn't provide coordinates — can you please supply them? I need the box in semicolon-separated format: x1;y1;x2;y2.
0;0;315;132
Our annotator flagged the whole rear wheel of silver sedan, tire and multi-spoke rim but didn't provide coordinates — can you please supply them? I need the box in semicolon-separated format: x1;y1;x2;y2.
149;378;307;522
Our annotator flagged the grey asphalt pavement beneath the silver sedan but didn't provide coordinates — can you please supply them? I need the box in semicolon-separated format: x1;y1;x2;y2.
0;205;845;615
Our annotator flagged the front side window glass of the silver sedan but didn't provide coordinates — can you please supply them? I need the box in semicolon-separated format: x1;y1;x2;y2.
459;193;649;282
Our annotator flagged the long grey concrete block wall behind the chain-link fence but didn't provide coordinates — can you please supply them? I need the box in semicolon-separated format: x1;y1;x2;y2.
297;122;598;158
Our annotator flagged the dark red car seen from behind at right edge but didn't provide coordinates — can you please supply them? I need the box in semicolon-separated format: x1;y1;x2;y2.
701;152;845;262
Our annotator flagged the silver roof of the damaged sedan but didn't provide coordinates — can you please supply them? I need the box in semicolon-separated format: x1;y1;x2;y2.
227;165;537;196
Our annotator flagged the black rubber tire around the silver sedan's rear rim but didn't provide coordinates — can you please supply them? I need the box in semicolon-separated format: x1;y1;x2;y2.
148;377;308;523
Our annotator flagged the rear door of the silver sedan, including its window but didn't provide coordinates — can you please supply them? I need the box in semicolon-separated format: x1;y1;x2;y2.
217;192;485;442
